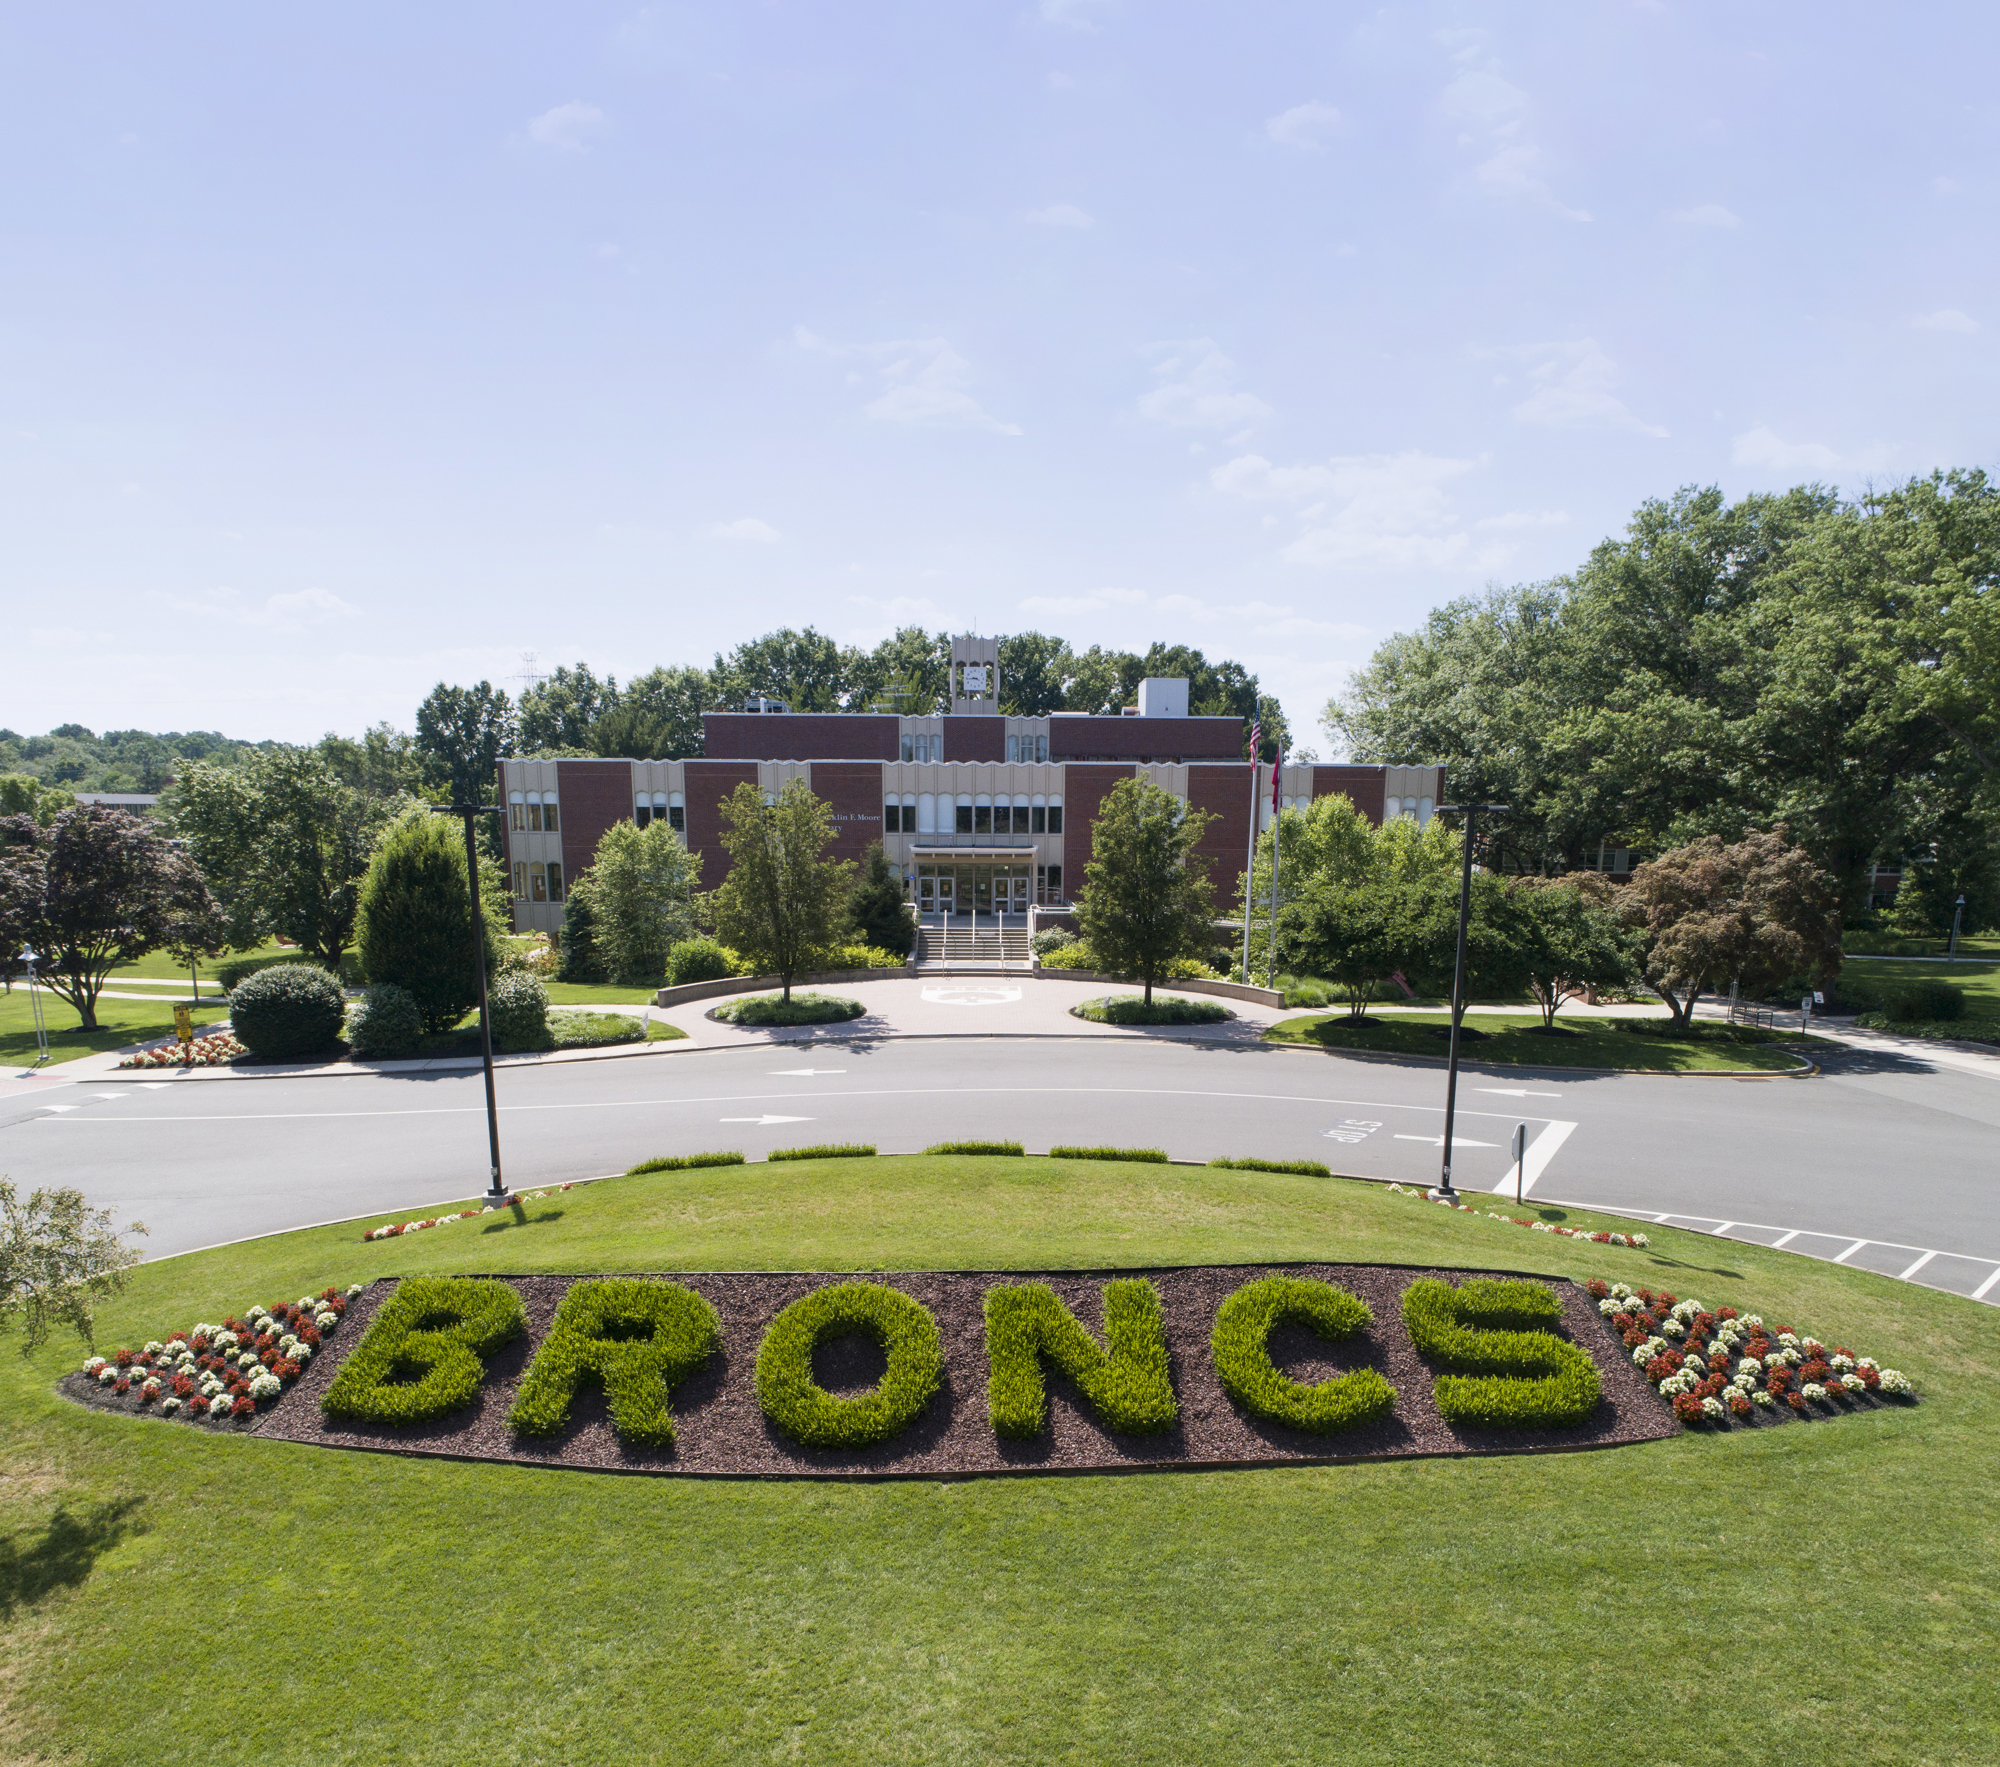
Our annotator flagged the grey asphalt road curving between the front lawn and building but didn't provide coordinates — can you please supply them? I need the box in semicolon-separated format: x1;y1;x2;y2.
0;1035;2000;1299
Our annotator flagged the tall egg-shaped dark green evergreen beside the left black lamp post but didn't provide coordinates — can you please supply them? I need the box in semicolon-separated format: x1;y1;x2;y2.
356;810;510;1035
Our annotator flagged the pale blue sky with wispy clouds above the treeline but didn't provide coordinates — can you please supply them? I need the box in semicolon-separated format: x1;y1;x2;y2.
0;0;2000;752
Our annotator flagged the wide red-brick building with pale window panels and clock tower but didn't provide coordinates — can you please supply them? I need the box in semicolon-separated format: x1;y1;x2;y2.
500;638;1444;931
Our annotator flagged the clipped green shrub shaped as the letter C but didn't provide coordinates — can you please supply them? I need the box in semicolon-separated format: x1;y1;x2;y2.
1208;1275;1396;1435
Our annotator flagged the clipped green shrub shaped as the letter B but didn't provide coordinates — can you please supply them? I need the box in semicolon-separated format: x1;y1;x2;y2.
320;1275;528;1425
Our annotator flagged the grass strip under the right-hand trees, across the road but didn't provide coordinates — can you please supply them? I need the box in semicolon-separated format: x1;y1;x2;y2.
1266;1013;1818;1073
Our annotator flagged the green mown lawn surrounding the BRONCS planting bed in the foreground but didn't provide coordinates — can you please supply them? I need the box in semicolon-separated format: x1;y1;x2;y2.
0;1147;2000;1767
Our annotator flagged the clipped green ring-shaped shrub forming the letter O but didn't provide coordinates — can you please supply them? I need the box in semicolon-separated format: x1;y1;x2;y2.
756;1283;944;1447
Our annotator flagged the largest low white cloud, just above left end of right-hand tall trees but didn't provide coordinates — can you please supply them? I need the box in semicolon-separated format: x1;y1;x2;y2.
1208;452;1506;570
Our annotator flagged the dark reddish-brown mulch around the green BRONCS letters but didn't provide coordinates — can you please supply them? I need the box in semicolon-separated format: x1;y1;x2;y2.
250;1263;1680;1479
